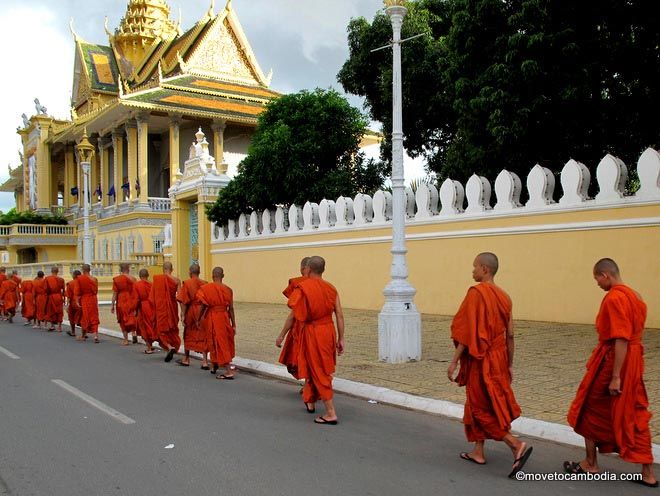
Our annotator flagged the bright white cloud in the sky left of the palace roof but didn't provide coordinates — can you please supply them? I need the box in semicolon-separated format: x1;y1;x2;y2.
0;6;74;211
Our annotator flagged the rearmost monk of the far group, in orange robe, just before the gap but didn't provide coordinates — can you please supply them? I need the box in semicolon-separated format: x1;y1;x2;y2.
197;267;236;380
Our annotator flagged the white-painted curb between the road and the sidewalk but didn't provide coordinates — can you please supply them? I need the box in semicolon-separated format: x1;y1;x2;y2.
99;327;660;461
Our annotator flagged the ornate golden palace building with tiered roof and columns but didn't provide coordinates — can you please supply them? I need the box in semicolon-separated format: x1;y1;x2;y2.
0;0;278;276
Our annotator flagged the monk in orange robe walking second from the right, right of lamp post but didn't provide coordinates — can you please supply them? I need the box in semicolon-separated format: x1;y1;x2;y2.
447;252;532;478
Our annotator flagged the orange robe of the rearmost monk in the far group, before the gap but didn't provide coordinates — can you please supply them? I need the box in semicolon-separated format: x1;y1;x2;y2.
197;282;236;365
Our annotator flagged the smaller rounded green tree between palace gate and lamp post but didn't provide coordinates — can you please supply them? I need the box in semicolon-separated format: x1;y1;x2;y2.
207;89;385;224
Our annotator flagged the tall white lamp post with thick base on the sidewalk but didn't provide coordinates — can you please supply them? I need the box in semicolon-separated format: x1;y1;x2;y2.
378;0;422;363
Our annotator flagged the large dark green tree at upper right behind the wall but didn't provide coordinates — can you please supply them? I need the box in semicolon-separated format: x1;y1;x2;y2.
338;0;660;186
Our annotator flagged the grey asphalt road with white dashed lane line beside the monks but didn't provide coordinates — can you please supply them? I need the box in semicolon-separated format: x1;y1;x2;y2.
0;319;651;496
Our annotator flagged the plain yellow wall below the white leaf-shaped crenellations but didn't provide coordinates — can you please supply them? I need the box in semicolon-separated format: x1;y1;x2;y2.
212;205;660;327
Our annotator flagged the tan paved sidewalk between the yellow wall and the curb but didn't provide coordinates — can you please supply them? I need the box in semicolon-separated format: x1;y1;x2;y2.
101;303;660;444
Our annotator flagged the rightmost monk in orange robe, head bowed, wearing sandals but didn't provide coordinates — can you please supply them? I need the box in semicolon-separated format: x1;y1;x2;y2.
564;258;658;487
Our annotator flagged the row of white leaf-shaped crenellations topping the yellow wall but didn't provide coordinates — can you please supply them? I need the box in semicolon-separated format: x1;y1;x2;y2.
211;148;660;243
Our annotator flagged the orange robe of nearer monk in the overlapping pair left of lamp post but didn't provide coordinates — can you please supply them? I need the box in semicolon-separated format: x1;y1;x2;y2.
288;278;337;403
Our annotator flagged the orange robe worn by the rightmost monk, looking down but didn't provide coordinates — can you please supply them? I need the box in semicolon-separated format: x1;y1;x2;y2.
568;284;653;464
